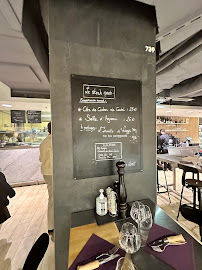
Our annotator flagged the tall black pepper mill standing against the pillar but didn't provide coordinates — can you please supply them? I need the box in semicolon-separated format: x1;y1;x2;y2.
116;161;128;218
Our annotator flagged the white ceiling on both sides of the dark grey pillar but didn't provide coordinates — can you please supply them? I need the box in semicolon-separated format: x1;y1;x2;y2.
0;0;202;105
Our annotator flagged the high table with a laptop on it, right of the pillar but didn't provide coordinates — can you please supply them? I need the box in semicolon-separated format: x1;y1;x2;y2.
156;154;202;190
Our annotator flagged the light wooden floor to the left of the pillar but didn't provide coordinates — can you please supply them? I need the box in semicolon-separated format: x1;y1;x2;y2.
0;185;54;270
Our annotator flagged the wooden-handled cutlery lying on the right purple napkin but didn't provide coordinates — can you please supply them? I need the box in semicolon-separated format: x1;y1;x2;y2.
149;234;186;252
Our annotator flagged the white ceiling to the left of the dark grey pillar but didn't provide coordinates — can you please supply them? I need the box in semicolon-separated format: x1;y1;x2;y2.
0;0;50;95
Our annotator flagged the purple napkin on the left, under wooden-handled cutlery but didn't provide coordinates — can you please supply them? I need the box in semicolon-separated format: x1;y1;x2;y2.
69;234;126;270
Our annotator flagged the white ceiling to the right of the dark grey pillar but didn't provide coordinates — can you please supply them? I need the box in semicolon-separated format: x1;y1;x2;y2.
140;0;202;99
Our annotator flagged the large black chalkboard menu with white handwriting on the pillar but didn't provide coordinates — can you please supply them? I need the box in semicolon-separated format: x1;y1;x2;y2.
71;75;142;179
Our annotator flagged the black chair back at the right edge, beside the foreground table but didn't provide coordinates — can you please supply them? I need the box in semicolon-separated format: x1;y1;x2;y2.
180;204;202;242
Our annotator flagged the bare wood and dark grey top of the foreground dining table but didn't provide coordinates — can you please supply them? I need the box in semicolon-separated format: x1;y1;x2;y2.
68;199;202;270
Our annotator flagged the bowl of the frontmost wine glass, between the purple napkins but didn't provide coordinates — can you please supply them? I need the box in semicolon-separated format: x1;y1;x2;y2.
119;222;141;254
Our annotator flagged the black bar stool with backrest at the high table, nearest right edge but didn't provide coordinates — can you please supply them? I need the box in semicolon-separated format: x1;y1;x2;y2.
177;164;202;220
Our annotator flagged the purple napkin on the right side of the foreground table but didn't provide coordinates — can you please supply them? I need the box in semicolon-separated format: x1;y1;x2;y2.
144;224;195;270
